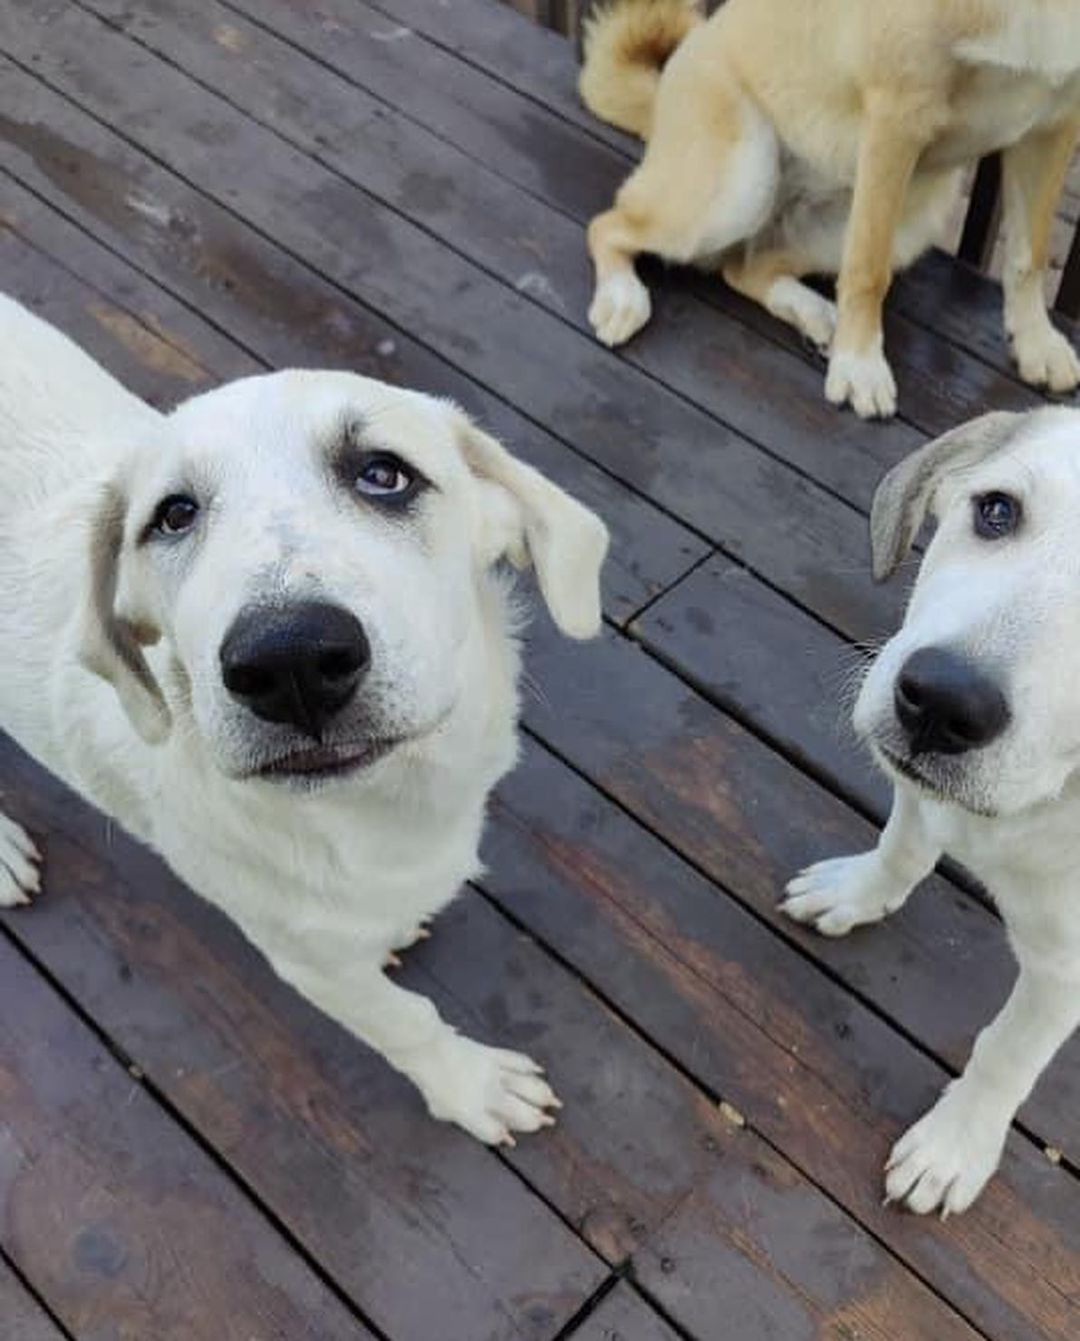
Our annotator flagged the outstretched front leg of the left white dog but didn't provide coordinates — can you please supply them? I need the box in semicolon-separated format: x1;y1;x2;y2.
270;939;559;1145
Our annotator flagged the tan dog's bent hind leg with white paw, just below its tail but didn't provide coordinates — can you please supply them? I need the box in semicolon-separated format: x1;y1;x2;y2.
589;53;779;345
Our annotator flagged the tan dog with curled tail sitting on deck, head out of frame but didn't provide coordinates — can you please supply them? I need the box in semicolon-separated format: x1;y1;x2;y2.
581;0;1080;417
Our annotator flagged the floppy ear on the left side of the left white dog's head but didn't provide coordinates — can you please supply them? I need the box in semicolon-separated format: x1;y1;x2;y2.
78;484;172;744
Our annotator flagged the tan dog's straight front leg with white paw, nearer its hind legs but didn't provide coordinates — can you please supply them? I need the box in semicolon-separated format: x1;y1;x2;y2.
825;90;930;418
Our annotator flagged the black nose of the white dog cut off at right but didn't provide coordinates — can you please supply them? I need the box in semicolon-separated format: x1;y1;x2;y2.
894;648;1009;754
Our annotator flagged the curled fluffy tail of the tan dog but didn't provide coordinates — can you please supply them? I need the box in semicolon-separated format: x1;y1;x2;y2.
578;0;704;139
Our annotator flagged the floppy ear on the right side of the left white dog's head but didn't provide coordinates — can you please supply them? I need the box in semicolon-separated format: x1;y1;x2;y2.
455;410;608;638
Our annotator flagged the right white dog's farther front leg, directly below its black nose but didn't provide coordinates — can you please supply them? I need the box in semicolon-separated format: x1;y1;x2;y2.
781;783;942;936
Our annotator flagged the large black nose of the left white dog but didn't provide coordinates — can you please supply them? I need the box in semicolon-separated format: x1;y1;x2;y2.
221;601;372;740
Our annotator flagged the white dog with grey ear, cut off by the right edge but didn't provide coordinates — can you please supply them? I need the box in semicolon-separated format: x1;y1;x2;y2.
784;409;1080;1215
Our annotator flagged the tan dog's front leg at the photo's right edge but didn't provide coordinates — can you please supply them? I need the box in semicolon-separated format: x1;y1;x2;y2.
1002;119;1080;392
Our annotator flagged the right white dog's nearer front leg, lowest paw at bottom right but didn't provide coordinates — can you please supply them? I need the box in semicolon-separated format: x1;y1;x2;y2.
885;955;1080;1218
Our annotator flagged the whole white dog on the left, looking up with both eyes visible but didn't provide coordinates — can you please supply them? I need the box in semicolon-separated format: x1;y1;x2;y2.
0;298;608;1144
